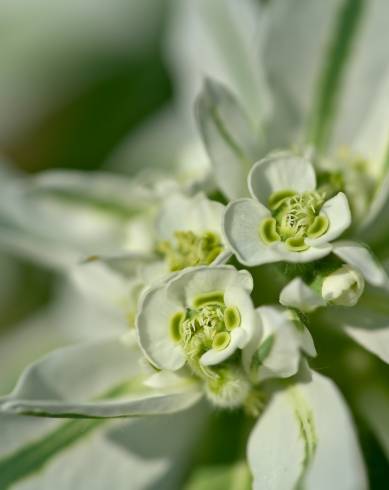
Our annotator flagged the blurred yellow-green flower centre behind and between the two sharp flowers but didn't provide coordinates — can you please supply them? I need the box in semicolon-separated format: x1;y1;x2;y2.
157;231;223;272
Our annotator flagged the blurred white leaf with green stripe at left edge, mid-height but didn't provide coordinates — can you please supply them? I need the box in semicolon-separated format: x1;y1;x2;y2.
0;171;156;269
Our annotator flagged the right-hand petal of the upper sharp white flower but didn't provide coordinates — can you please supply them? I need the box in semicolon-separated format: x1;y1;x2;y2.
306;192;351;247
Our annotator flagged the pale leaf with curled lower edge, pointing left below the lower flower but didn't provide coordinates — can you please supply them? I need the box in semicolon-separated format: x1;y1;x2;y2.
0;338;201;418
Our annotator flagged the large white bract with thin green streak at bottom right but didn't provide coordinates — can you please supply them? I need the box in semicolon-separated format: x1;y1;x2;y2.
248;373;367;490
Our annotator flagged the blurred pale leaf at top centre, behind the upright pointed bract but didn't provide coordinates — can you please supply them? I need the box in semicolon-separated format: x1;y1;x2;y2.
167;0;269;130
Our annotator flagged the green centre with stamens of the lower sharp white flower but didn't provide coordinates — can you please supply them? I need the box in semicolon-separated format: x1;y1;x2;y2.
169;291;241;375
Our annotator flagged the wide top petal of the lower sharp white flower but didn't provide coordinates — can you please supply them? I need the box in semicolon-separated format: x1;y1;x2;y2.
168;265;253;306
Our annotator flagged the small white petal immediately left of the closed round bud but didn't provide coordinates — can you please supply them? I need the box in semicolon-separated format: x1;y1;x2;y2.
280;277;326;313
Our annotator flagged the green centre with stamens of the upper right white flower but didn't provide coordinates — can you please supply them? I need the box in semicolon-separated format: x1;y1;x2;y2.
258;190;329;252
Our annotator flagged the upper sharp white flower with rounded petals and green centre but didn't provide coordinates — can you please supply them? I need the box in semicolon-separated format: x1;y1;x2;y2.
224;155;351;265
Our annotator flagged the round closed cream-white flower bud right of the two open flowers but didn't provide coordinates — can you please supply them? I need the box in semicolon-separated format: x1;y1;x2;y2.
321;265;365;306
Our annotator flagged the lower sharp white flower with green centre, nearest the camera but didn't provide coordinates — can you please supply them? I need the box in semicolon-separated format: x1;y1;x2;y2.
137;266;257;374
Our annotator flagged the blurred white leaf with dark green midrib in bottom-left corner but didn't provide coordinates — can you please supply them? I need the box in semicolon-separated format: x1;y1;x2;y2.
0;404;208;490
